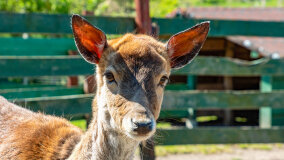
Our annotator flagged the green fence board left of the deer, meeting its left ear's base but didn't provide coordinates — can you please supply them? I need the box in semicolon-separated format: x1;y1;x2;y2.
0;56;94;77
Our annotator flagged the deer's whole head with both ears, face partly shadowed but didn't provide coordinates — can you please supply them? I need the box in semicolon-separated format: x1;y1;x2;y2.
72;15;209;141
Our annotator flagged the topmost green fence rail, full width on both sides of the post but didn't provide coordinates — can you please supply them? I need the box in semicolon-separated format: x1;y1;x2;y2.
0;13;284;37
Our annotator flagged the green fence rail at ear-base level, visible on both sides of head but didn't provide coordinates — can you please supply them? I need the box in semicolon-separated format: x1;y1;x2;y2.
0;56;284;77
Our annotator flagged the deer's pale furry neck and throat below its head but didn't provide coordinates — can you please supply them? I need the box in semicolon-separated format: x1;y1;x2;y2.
69;87;139;160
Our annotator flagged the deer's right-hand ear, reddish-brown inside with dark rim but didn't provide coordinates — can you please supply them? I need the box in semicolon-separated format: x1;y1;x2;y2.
167;22;210;68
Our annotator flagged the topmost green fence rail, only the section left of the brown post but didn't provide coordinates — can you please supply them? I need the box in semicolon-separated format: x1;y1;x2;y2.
0;13;135;34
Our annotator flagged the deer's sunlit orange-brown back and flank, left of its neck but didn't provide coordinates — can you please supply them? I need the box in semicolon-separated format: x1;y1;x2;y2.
0;97;82;160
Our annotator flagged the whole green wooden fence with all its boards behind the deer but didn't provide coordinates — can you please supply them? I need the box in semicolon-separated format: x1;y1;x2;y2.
0;13;284;145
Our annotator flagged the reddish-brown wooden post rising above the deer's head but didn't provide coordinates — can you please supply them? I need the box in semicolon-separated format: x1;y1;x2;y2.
135;0;152;35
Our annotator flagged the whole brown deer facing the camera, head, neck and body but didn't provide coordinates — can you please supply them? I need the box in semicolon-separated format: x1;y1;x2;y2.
0;15;209;160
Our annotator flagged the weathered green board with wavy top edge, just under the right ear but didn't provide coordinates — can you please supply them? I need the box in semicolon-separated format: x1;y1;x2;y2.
172;56;284;76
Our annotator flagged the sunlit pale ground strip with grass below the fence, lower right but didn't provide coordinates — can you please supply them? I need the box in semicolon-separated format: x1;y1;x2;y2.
135;144;284;160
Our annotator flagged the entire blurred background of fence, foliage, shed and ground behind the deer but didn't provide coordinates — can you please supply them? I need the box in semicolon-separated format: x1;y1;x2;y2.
0;0;284;160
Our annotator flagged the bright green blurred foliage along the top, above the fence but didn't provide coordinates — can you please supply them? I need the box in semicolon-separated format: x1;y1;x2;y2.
0;0;284;17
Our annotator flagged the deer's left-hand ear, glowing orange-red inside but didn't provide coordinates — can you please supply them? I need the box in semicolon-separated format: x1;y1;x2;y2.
71;15;107;64
